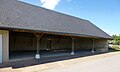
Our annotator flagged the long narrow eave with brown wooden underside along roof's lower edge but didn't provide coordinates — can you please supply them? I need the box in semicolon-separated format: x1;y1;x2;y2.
0;27;113;40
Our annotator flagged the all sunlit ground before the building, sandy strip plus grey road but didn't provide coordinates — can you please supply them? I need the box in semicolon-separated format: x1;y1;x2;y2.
0;52;120;72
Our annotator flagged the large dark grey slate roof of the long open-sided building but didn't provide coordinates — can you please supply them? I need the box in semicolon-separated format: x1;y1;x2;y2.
0;0;111;39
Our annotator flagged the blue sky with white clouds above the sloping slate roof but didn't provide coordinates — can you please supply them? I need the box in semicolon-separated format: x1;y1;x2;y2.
20;0;120;35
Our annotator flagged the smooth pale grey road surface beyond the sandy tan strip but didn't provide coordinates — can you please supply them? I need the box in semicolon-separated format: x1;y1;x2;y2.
41;54;120;72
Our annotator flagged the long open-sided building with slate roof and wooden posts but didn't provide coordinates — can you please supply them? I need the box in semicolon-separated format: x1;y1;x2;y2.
0;0;111;63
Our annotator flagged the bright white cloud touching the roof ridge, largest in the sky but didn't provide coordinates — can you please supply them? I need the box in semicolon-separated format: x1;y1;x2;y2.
40;0;60;10
